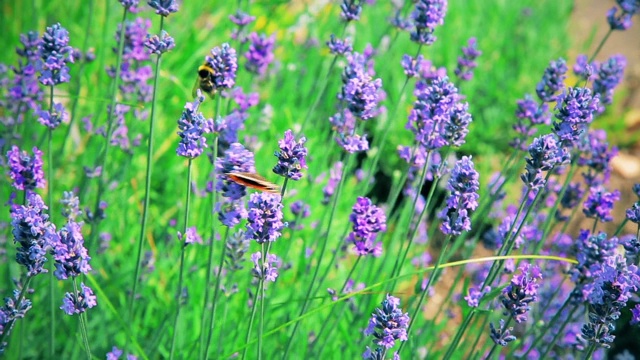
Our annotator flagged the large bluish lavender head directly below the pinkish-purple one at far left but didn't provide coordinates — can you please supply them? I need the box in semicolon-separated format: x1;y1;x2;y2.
11;192;55;277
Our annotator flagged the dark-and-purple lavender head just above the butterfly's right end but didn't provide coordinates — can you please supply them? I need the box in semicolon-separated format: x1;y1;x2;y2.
273;130;307;181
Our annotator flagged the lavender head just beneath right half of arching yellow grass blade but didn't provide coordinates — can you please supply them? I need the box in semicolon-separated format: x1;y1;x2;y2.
500;264;542;323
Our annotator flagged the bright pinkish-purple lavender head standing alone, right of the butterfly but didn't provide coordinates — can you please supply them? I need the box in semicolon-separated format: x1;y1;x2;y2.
347;196;387;257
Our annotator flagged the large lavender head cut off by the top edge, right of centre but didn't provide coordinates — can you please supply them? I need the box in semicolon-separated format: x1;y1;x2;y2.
411;0;447;45
